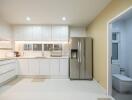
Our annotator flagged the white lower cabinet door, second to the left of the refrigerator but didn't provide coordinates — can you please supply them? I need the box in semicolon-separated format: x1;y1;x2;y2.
50;59;60;75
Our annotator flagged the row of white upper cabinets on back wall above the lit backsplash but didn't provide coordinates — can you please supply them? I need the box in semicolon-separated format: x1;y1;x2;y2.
14;25;69;41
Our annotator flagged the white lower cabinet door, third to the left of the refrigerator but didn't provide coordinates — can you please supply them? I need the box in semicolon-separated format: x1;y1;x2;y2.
39;59;50;75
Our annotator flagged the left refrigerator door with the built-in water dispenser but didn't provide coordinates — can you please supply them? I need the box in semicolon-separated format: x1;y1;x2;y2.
70;38;80;79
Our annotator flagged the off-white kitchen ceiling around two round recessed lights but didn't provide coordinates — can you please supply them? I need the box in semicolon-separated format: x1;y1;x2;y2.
0;0;111;25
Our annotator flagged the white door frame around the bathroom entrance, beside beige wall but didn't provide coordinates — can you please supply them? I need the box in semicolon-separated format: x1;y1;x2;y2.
107;6;132;96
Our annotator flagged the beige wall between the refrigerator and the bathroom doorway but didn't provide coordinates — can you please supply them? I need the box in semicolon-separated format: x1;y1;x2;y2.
87;0;132;88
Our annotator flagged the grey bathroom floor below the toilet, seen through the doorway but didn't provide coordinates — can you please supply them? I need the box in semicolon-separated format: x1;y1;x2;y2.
112;89;132;100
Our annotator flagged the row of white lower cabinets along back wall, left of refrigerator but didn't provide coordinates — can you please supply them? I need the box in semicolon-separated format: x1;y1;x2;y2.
18;58;69;77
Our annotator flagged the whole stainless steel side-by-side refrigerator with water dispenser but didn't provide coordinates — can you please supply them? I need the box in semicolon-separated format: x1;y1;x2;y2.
70;38;93;80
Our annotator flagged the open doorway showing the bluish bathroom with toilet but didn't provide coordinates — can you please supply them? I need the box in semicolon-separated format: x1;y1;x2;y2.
107;7;132;100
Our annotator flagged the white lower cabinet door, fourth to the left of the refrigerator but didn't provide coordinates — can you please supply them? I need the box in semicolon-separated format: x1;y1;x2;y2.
28;59;39;75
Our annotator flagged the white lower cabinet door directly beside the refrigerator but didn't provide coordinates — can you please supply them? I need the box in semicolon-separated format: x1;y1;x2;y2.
60;59;69;76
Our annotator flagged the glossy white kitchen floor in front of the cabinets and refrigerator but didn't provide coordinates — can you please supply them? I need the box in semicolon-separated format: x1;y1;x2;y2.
0;79;112;100
